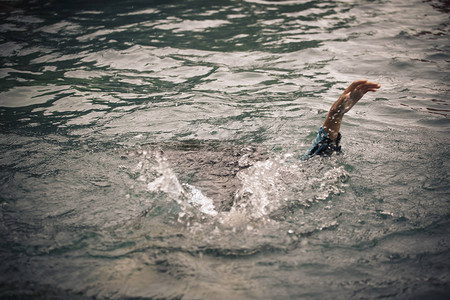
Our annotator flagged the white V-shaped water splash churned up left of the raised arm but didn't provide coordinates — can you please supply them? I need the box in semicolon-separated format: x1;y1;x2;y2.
130;145;348;228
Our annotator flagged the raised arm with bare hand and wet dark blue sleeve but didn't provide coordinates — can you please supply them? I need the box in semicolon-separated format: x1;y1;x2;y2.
303;80;380;159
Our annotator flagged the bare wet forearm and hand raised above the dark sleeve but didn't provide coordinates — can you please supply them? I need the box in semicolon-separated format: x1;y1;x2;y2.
322;80;380;141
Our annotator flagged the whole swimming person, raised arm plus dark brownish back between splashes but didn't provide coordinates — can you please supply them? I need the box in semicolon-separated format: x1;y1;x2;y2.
133;80;380;211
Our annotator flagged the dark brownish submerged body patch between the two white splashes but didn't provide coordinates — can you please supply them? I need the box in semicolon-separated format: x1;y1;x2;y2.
135;141;269;211
